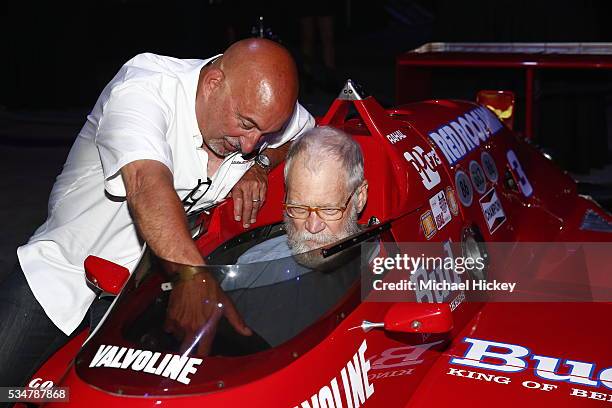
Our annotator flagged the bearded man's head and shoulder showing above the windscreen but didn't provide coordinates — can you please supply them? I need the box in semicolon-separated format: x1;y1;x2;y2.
238;127;368;268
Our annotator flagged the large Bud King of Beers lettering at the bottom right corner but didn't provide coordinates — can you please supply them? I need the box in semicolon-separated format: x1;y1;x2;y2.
446;337;612;402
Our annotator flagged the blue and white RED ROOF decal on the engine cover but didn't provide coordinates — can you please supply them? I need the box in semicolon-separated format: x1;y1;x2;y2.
429;106;504;165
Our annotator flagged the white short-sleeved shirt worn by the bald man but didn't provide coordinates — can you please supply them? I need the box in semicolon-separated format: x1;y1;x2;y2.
17;54;314;334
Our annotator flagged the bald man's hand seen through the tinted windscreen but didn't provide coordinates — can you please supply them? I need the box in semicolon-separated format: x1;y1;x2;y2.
164;272;253;356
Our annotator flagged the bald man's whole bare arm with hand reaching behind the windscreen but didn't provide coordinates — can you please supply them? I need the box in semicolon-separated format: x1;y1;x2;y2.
121;160;252;355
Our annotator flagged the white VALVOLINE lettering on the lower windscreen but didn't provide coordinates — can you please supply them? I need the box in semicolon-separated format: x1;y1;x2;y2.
89;344;203;384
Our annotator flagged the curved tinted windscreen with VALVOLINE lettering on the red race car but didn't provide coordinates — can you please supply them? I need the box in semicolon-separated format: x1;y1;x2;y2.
76;235;374;395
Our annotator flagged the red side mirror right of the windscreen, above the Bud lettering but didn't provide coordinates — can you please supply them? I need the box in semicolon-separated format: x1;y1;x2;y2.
361;302;453;333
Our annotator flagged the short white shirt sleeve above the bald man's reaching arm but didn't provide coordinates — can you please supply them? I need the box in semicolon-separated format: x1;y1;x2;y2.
95;84;173;197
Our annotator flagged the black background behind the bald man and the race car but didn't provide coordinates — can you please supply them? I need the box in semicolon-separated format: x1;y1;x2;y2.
0;0;612;270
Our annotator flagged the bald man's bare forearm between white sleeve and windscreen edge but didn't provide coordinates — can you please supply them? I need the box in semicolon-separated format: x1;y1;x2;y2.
121;160;204;265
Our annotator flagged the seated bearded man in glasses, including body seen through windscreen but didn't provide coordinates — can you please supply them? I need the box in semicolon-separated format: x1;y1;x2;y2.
221;127;368;346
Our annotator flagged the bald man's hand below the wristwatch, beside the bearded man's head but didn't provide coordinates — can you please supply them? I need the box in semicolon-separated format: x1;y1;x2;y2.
231;165;268;228
